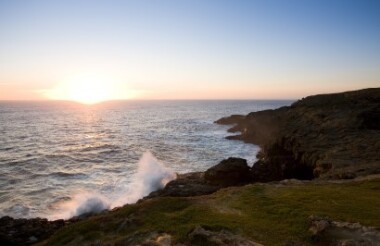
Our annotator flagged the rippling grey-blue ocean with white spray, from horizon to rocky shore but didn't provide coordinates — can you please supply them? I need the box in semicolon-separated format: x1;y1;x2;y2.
0;100;292;219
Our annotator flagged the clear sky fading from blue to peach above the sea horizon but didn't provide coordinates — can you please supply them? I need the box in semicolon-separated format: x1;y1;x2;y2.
0;0;380;102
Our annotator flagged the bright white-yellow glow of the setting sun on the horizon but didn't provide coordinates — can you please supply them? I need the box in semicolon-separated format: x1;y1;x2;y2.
42;76;136;104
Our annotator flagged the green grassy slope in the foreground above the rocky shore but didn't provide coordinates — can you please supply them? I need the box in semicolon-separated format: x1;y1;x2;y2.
42;179;380;245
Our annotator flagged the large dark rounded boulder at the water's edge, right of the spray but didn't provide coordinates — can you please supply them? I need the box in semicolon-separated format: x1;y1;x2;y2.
204;157;251;187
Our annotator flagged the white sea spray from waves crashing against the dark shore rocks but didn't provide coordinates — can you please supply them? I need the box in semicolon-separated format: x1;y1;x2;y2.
48;152;176;220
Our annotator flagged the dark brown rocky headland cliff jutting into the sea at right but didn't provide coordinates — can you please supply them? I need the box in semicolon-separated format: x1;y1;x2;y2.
216;88;380;182
